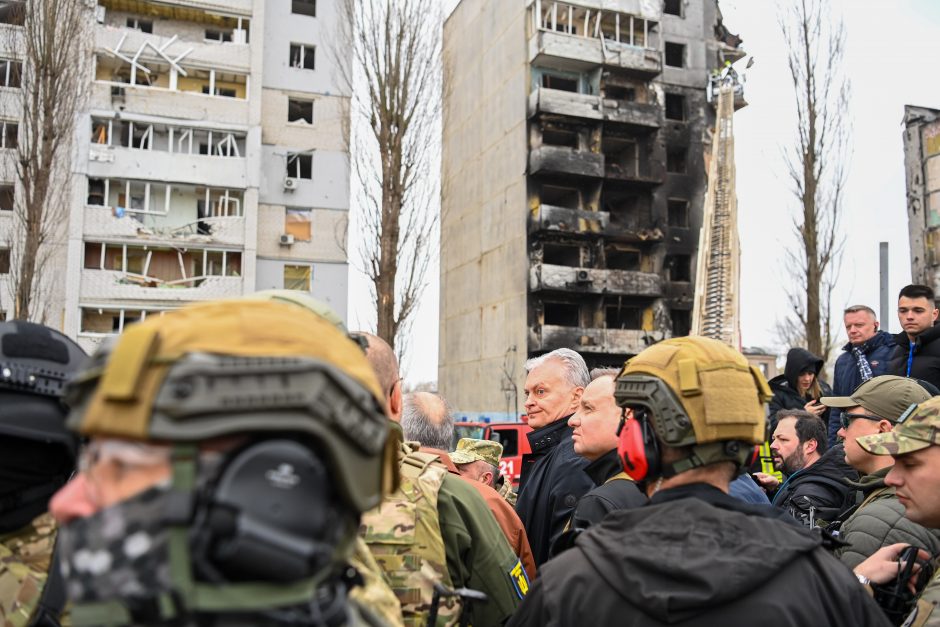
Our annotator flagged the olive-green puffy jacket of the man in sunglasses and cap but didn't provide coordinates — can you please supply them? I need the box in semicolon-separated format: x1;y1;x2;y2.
834;466;940;568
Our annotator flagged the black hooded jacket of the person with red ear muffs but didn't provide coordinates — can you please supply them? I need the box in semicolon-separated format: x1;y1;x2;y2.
509;484;890;627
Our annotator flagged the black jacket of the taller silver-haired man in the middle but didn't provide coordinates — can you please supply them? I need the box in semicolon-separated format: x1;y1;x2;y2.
516;417;594;566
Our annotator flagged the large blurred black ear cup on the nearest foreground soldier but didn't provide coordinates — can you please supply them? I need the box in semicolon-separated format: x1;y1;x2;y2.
191;437;356;582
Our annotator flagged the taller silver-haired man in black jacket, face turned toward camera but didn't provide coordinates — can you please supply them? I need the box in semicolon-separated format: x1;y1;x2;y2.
516;348;594;566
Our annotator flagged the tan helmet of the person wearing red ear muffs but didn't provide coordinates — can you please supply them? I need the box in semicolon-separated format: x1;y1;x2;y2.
614;336;772;474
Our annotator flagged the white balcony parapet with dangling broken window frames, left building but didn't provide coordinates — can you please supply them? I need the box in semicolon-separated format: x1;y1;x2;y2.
95;24;251;74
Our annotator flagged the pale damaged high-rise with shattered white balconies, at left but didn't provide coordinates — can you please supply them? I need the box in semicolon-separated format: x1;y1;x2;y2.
4;0;349;349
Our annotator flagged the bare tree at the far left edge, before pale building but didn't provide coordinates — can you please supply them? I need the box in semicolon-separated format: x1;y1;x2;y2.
4;0;91;321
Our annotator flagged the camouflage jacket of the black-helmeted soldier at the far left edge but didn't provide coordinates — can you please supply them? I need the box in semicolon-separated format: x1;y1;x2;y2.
0;513;69;627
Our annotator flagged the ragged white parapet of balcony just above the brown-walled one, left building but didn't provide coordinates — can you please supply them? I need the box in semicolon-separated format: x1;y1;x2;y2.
82;205;245;246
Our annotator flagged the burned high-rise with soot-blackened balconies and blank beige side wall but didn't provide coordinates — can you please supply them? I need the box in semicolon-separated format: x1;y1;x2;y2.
439;0;743;419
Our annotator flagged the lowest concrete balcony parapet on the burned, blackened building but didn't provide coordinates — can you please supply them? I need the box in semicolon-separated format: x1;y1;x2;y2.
529;324;671;355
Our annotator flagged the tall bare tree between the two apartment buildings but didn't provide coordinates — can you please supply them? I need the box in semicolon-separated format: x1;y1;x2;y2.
335;0;441;359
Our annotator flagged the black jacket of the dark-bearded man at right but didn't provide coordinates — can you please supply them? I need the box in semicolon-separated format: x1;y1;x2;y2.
771;444;858;525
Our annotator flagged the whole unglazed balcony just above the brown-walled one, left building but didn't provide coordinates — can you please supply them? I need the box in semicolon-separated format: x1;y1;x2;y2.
85;178;245;245
